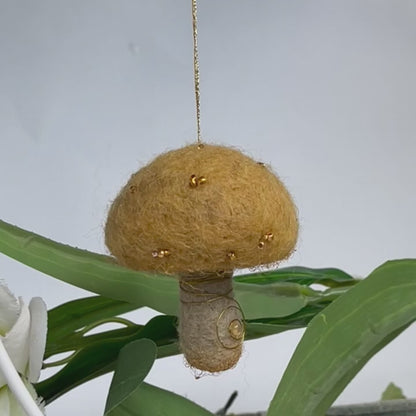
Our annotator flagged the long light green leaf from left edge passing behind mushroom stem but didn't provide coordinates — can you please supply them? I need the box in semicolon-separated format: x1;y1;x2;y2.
0;221;342;319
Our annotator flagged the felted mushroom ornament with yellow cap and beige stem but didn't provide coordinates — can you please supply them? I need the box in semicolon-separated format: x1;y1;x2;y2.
105;144;298;372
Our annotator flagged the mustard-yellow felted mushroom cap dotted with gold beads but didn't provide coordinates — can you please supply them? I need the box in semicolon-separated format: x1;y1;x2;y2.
105;144;298;274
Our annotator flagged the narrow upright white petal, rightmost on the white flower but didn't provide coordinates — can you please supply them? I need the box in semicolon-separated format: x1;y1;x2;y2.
28;298;48;383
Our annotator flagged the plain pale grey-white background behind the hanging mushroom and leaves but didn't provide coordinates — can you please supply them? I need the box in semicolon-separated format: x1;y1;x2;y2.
0;0;416;416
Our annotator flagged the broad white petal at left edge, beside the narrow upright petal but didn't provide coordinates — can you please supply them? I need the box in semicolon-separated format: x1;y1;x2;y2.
0;299;30;386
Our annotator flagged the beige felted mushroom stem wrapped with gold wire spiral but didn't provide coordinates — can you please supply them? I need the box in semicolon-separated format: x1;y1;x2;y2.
179;272;244;373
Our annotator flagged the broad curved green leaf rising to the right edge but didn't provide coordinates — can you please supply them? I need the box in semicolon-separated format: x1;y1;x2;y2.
267;259;416;416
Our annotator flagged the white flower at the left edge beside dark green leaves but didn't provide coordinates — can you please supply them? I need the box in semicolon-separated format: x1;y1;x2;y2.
0;284;47;416
